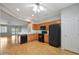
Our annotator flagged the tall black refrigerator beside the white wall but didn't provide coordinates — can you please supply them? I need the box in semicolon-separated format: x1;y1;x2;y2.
49;24;61;47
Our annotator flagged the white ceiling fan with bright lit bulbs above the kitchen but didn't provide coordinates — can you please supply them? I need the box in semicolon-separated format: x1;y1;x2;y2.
27;3;46;13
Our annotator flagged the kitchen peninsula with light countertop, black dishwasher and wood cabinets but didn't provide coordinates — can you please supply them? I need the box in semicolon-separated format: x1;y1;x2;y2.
19;33;38;44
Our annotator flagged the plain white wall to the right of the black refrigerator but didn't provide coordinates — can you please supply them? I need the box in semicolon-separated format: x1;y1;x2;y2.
61;4;79;53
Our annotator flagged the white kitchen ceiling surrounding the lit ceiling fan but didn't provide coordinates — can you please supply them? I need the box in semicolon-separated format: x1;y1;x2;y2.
2;3;74;22
